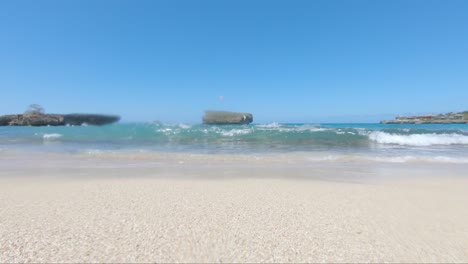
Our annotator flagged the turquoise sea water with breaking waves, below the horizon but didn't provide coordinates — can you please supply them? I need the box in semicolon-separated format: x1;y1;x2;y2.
0;123;468;163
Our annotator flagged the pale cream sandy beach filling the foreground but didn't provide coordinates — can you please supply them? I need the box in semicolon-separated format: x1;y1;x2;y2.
0;163;468;263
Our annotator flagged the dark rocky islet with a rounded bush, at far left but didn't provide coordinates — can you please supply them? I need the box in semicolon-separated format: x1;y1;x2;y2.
0;105;120;126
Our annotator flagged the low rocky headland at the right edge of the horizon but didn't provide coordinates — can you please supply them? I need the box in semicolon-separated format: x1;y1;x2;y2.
380;111;468;124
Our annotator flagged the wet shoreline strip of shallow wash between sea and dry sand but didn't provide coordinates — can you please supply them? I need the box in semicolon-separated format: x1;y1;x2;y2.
0;152;468;182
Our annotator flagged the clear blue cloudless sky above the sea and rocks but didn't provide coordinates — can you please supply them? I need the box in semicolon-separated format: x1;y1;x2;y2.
0;0;468;123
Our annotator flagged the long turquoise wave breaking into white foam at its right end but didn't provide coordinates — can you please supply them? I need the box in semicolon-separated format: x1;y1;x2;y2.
138;123;468;147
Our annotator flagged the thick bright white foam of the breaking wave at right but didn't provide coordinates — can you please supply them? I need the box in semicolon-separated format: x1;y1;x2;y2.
369;131;468;147
